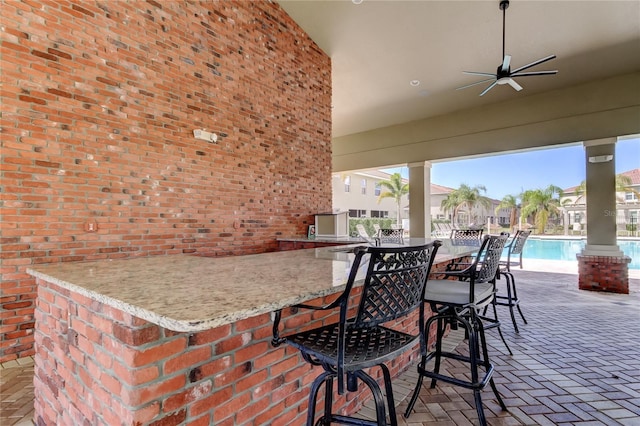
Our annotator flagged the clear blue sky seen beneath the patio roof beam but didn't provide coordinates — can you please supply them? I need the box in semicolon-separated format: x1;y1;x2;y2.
385;138;640;200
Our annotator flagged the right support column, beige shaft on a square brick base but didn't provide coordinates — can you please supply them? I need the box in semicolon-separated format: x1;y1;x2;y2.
577;138;631;294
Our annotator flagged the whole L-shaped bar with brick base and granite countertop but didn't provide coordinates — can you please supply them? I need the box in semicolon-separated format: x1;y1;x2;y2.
27;239;475;425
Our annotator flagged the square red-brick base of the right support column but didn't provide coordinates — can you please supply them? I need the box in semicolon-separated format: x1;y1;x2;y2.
576;255;631;294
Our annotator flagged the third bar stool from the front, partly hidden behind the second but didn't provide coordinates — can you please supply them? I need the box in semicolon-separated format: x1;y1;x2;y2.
494;231;531;333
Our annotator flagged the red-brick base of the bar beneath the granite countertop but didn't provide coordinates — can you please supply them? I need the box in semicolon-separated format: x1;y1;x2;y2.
34;281;424;426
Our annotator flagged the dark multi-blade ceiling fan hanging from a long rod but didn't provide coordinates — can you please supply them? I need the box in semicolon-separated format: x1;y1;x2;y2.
456;0;558;96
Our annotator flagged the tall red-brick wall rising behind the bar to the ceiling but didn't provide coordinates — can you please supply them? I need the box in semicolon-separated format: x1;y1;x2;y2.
0;0;331;361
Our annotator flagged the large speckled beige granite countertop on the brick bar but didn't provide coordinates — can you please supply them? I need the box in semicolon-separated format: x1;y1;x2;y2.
27;240;473;332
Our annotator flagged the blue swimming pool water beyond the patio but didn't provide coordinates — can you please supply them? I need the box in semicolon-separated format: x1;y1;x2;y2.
522;237;640;269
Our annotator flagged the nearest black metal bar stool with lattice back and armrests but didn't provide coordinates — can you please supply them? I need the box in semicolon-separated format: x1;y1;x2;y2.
273;241;440;426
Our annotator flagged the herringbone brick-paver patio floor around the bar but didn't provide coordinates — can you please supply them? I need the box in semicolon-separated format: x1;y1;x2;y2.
0;268;640;426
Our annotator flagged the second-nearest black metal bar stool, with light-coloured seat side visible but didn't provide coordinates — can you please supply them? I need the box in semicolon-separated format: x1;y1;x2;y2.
404;235;507;425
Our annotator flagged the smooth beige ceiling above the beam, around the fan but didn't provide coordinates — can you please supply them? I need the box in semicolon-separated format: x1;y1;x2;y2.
278;0;640;137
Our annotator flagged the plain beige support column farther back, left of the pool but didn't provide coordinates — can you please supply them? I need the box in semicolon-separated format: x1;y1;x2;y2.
408;161;431;238
